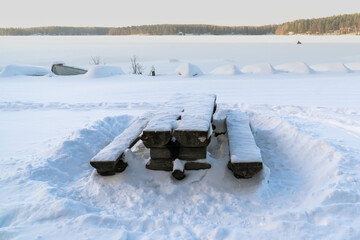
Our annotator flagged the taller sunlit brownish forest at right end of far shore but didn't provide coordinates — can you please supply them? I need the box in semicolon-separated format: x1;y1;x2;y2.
275;13;360;35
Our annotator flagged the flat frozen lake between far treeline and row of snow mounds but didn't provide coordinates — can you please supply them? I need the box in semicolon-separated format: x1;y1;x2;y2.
0;35;360;67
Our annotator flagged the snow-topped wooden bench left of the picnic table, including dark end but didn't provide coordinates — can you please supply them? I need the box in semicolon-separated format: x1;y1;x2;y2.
90;117;149;176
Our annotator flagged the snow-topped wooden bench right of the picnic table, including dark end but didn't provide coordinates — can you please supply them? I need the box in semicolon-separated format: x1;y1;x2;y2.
226;111;263;178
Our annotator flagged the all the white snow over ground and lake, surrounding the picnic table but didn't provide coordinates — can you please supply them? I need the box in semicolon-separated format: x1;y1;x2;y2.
0;36;360;239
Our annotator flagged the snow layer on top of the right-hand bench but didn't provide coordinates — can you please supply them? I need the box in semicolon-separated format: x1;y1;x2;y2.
226;111;262;163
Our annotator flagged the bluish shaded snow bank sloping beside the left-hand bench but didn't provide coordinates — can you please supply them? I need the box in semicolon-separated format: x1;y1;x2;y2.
30;115;133;185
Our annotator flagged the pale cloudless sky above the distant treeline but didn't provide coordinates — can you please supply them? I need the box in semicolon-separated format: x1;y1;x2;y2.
0;0;360;27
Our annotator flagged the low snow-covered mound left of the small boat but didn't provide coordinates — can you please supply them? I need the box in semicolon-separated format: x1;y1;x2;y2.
0;65;51;77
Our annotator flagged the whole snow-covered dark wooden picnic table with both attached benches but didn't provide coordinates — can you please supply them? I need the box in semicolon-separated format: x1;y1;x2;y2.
90;94;262;180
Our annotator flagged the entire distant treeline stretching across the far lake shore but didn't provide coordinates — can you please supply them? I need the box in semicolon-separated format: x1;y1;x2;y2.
0;13;360;36
